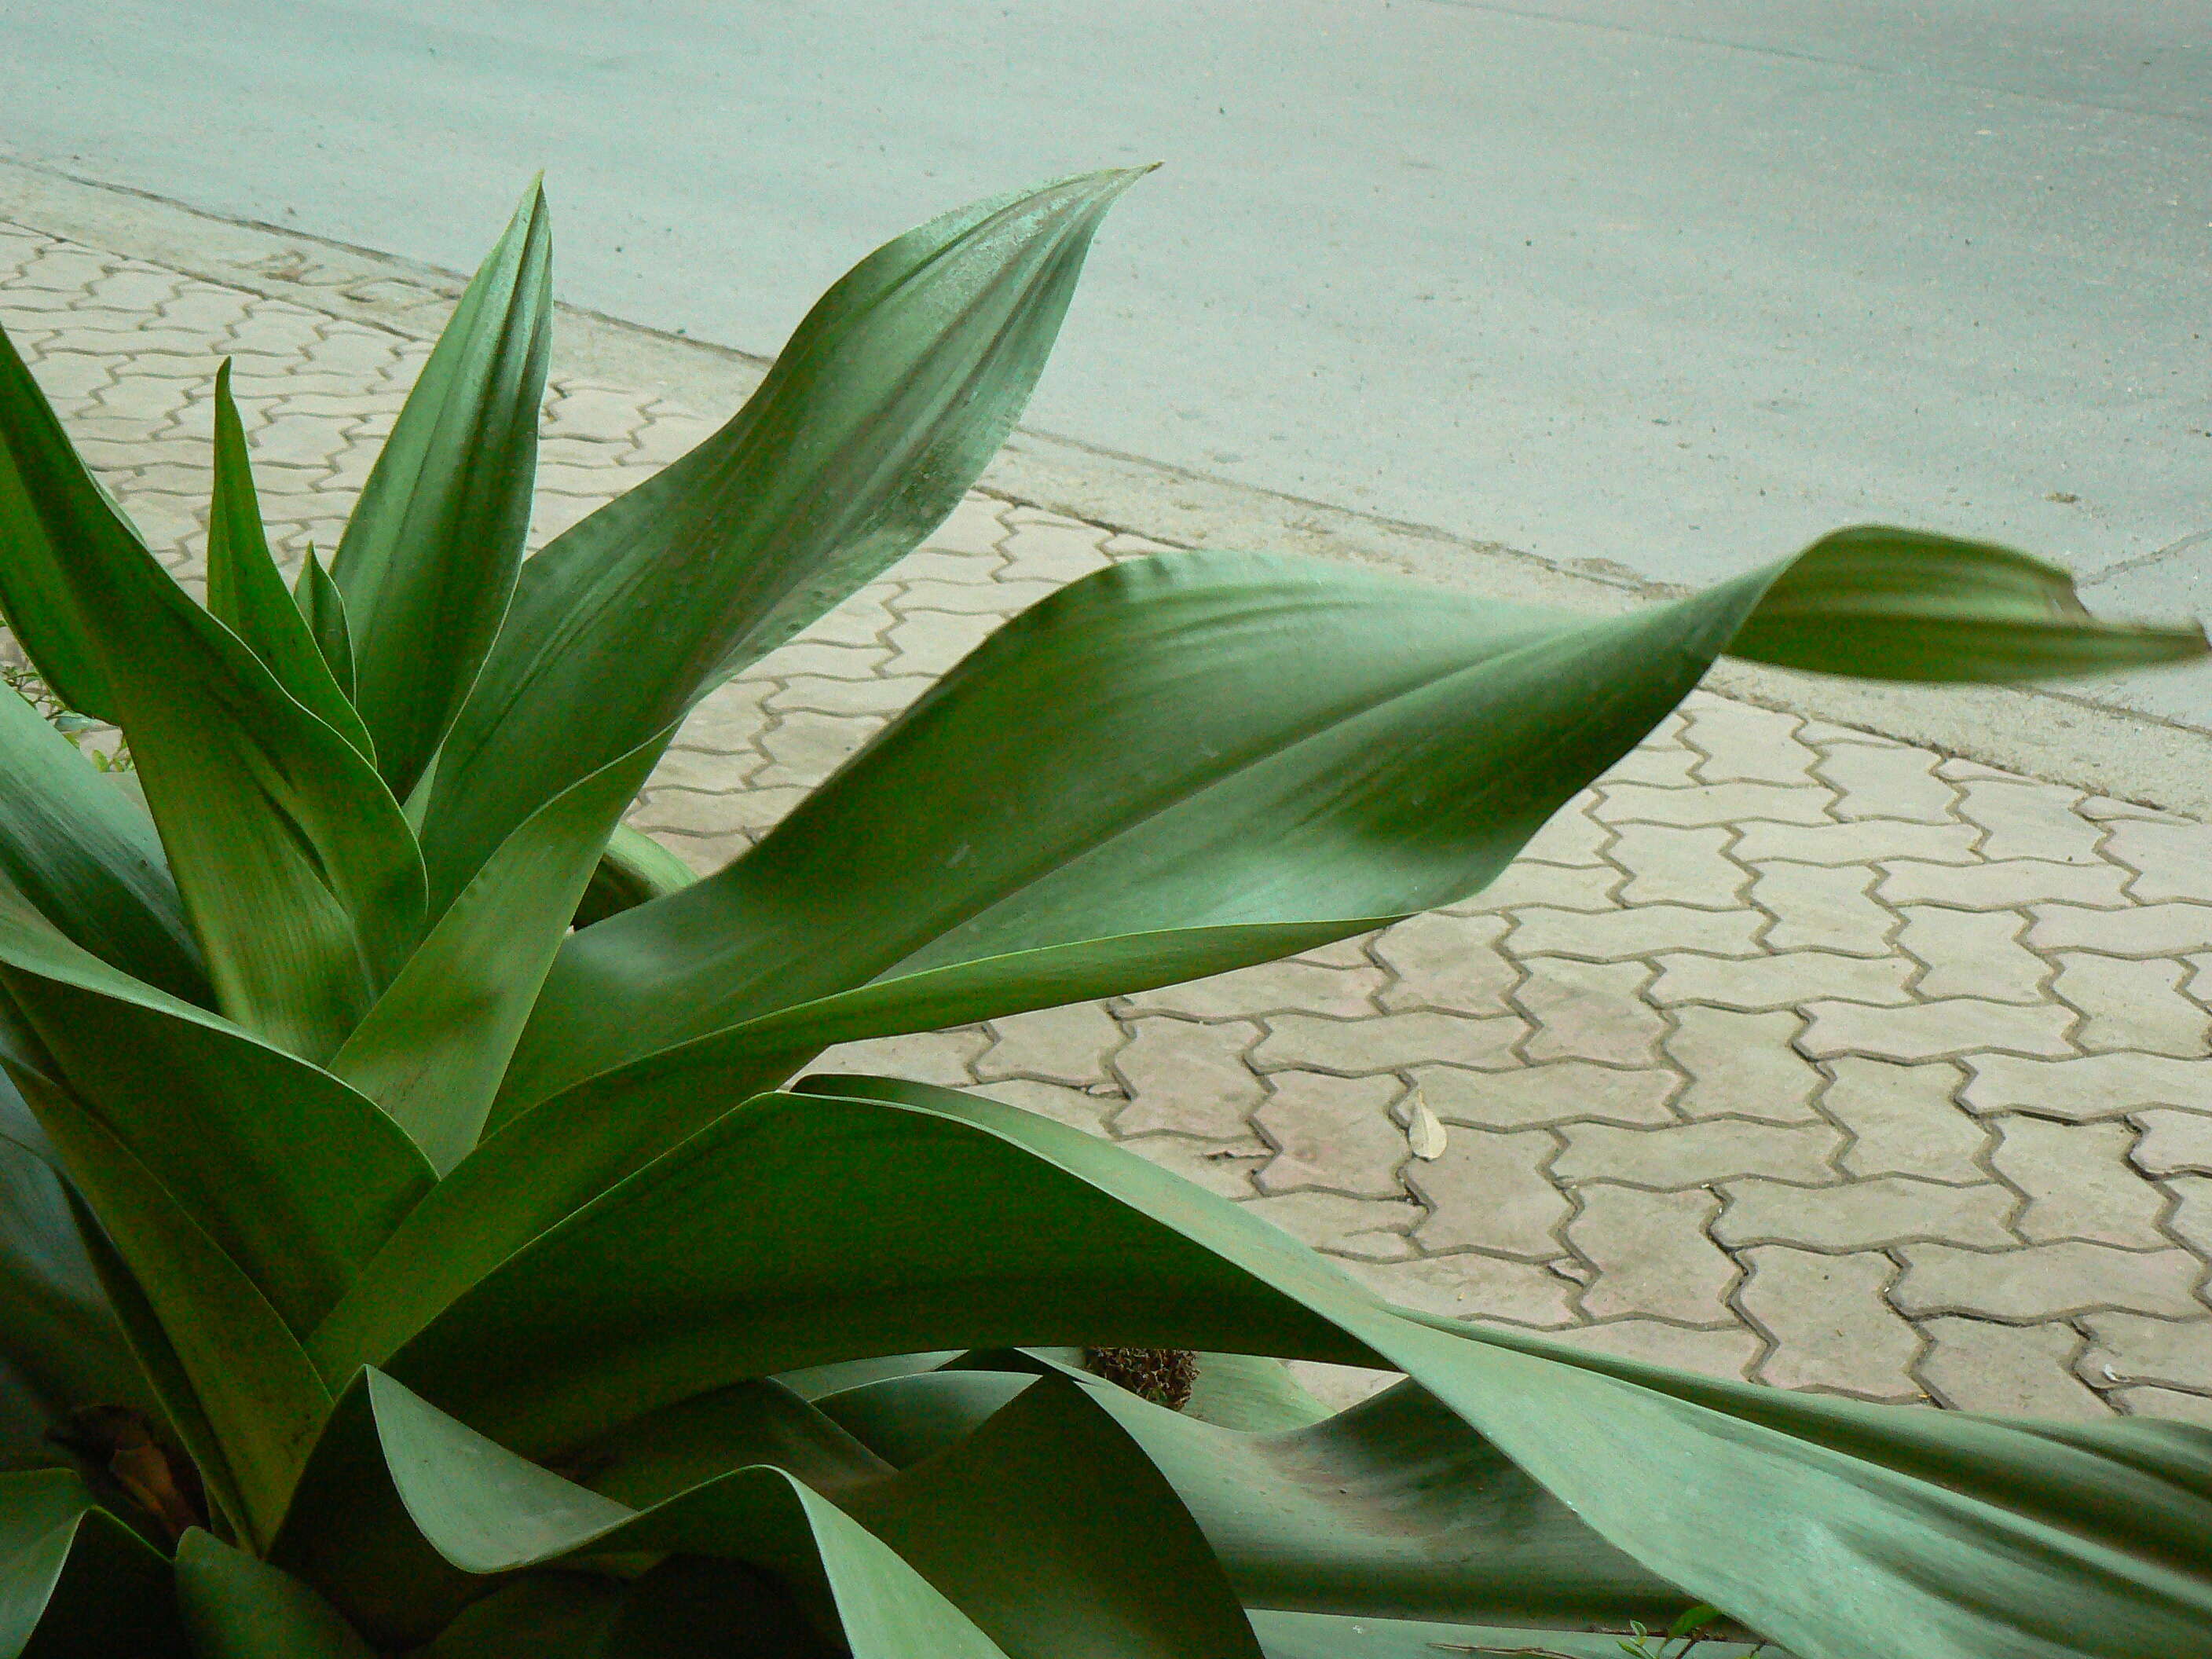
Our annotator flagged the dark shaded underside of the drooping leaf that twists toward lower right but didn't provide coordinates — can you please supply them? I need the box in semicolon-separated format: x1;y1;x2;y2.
309;1095;1372;1456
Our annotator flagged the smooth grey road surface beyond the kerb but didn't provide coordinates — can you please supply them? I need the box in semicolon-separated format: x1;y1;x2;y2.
0;0;2212;727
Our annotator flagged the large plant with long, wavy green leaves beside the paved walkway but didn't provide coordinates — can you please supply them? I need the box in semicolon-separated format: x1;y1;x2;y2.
0;174;2212;1659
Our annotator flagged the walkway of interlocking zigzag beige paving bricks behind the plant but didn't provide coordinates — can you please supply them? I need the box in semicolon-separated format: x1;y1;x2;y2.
0;211;2212;1423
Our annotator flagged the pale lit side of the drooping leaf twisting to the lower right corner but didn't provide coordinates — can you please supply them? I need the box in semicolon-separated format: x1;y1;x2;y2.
819;1077;2212;1659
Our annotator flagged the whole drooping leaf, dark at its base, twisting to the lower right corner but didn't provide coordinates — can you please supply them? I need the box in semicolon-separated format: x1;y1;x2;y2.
340;1077;2212;1659
